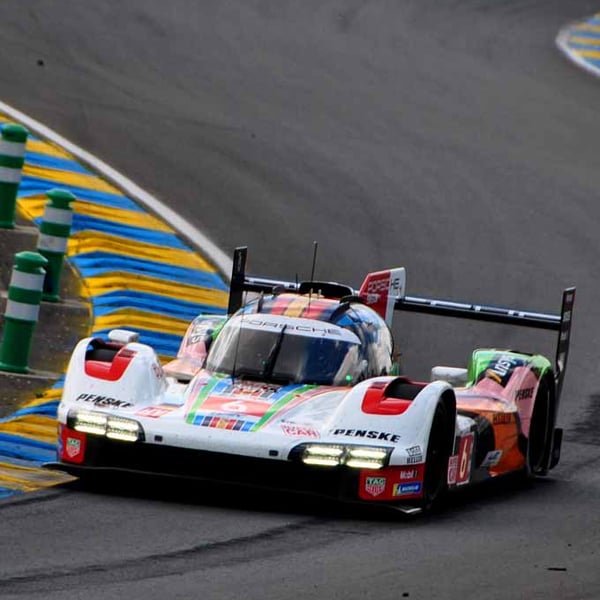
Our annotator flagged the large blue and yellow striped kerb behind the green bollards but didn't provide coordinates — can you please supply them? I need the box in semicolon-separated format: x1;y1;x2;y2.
0;113;228;498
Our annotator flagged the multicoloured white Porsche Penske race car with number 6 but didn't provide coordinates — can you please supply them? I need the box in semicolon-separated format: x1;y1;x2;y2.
52;248;575;513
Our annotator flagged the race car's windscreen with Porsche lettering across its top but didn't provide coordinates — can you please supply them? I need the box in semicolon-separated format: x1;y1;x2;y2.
206;317;362;385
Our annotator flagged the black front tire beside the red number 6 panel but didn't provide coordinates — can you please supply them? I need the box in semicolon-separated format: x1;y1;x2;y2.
422;403;454;510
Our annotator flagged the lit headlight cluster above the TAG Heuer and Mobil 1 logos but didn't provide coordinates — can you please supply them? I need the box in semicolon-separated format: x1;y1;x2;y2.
293;444;391;469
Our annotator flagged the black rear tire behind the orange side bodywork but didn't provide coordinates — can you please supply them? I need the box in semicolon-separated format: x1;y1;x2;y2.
526;381;552;477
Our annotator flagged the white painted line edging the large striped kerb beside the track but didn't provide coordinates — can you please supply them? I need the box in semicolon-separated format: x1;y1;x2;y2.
0;102;232;279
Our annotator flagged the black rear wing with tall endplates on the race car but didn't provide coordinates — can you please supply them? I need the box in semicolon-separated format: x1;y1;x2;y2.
227;247;575;398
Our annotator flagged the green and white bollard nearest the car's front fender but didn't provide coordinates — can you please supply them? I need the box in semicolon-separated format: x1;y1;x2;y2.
0;252;48;373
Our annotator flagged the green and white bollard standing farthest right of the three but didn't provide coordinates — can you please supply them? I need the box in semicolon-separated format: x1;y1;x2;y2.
37;189;77;302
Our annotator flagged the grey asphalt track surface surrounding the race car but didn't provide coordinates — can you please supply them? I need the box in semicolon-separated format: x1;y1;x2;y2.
0;0;600;600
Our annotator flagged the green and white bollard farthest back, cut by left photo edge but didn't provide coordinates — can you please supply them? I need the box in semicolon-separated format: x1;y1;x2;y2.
0;123;28;229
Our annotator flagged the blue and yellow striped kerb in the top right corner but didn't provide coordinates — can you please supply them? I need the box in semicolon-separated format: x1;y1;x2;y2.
556;13;600;76
